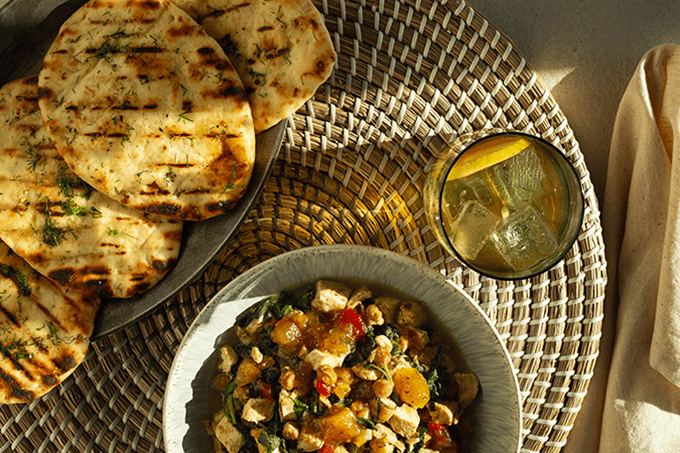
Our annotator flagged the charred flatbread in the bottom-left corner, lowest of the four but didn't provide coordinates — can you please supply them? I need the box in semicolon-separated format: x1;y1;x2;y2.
0;242;99;404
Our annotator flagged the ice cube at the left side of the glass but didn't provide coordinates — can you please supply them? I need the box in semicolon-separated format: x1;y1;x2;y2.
448;200;501;260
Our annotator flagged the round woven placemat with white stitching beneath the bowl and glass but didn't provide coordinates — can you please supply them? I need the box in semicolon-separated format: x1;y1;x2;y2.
0;0;606;453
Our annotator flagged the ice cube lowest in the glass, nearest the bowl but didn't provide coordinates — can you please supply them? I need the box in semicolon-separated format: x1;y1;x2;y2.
491;205;557;271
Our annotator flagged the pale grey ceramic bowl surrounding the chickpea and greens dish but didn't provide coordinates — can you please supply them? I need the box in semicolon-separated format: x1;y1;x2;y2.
163;245;521;453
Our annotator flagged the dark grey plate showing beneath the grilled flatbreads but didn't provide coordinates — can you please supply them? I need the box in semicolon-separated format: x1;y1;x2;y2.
0;0;285;339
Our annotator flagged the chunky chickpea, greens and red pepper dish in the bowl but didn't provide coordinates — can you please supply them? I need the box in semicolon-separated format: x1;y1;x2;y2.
206;280;479;453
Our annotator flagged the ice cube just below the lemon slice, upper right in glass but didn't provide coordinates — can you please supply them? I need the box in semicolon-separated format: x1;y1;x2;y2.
486;146;546;210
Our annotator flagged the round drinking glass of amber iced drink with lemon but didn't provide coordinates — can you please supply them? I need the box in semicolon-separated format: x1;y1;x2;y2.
423;129;584;280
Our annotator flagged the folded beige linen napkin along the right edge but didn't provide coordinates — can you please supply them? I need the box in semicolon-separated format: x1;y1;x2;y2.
562;45;680;453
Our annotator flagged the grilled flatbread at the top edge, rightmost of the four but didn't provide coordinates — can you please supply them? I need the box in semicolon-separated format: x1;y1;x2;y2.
173;0;337;133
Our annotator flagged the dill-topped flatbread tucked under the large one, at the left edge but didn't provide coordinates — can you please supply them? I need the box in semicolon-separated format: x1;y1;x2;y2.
0;76;183;298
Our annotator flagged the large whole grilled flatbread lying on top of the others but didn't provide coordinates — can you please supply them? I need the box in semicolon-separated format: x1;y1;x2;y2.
39;0;255;220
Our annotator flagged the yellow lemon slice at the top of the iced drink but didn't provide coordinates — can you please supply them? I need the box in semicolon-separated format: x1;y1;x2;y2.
446;138;531;181
